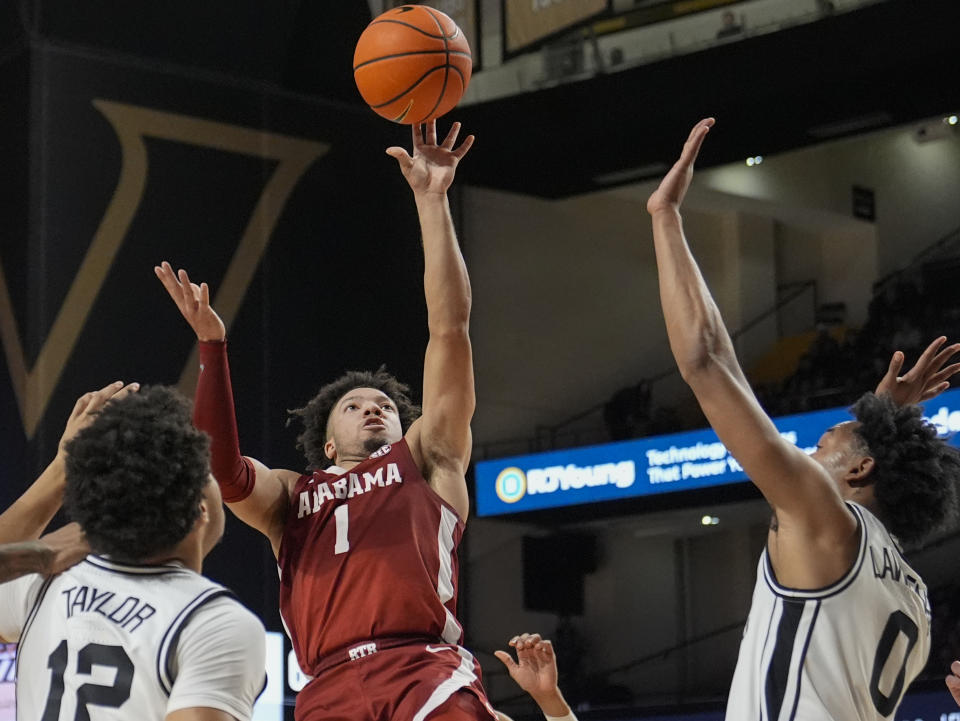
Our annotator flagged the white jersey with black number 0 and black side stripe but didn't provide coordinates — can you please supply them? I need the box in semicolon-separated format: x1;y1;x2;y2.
726;503;930;721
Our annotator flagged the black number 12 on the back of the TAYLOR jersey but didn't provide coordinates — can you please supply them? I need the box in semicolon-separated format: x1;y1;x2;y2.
40;640;133;721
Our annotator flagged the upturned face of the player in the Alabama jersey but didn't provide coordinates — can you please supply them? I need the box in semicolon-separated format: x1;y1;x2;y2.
327;388;403;458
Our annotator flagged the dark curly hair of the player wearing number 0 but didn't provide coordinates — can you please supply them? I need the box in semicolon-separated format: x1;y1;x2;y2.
851;393;960;546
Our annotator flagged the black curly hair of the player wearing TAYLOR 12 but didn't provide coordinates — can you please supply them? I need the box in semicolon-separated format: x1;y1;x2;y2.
64;386;210;563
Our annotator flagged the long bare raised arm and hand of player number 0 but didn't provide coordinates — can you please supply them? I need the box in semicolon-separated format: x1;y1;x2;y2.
647;118;859;589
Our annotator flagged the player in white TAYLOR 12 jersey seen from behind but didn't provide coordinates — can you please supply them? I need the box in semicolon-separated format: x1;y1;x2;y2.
0;386;265;721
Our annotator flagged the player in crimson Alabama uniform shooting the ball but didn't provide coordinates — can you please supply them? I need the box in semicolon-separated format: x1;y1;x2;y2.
155;122;493;721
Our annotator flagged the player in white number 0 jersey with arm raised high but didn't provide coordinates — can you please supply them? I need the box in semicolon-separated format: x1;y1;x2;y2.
647;118;960;721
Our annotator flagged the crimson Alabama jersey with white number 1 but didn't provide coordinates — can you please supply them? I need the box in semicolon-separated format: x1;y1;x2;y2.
277;439;463;676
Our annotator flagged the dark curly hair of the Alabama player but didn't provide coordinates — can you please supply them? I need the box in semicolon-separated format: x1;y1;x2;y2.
288;366;420;471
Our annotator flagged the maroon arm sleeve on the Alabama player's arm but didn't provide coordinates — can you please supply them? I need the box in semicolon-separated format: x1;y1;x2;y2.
193;340;256;503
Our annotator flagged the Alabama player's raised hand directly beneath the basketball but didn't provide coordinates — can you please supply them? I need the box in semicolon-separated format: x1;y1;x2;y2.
387;120;474;194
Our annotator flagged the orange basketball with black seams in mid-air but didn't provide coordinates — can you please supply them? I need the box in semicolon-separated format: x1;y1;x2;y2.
353;5;473;125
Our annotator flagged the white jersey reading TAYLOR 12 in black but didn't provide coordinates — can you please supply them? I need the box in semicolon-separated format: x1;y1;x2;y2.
6;556;264;721
